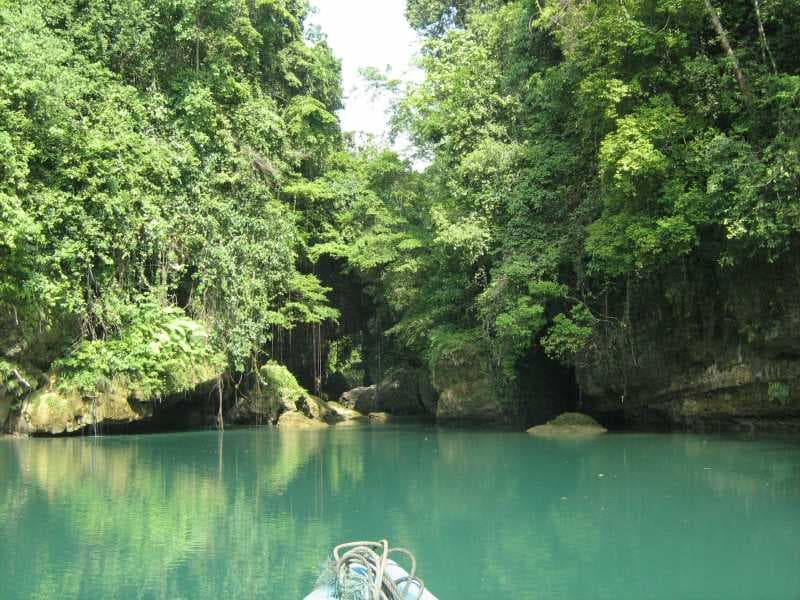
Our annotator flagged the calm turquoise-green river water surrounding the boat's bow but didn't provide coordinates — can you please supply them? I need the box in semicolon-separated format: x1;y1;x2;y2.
0;427;800;600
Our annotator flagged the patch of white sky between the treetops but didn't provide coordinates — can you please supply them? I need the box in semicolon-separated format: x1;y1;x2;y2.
309;0;422;154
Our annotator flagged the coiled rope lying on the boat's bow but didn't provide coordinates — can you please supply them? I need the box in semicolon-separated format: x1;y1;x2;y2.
322;540;425;600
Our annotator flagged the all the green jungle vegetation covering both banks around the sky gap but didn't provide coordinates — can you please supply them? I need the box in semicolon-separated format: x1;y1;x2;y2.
0;0;800;422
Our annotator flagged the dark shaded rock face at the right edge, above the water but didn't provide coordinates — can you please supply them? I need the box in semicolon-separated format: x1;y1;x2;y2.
577;249;800;430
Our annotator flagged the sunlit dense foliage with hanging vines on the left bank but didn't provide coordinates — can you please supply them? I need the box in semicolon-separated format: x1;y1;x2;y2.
0;0;341;404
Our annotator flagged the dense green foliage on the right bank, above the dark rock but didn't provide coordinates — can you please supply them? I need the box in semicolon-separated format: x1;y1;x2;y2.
326;0;800;404
